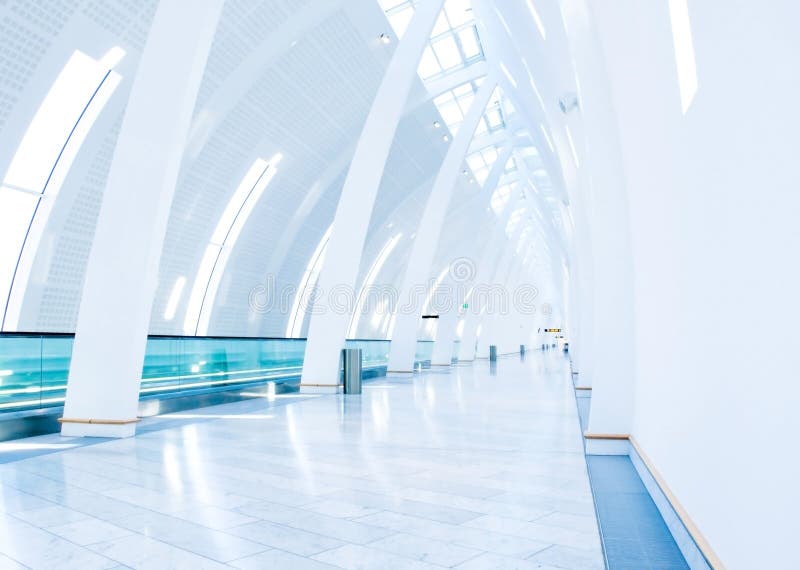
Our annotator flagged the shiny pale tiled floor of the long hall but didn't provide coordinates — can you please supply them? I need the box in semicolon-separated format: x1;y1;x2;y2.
0;352;603;570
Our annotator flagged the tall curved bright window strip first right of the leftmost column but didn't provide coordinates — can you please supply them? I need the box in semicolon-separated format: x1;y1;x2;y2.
183;153;283;335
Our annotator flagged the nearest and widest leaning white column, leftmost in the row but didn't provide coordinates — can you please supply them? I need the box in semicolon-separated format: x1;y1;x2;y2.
61;0;223;437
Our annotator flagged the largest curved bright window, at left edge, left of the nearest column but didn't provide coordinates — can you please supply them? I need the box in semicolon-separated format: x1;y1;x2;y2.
0;47;125;330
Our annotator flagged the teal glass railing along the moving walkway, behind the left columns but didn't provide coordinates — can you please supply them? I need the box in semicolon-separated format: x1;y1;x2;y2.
0;333;450;412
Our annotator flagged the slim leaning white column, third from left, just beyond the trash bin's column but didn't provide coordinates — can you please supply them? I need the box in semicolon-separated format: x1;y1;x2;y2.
388;76;497;373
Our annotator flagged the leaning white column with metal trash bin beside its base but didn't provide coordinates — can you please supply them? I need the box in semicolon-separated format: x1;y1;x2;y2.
300;0;444;392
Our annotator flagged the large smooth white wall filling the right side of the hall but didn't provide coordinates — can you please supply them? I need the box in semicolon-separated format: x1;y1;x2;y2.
565;0;800;569
